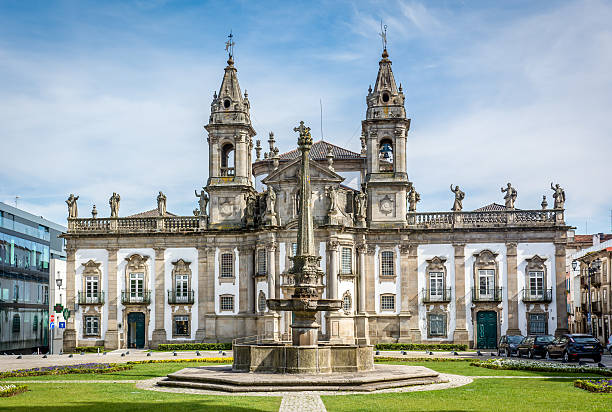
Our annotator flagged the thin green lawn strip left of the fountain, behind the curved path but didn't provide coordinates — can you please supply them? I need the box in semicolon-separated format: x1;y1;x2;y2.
0;362;229;382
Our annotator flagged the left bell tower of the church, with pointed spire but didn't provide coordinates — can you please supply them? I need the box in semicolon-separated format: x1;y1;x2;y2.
204;34;256;228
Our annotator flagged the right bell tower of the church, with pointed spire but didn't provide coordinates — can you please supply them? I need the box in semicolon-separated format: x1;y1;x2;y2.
361;45;410;227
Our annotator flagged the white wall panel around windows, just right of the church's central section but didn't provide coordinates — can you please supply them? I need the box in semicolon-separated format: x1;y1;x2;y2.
417;244;454;341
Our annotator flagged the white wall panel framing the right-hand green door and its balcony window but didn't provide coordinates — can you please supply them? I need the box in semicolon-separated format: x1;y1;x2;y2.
465;243;508;340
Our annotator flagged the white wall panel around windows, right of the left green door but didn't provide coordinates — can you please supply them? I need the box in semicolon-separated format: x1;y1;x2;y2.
164;248;199;340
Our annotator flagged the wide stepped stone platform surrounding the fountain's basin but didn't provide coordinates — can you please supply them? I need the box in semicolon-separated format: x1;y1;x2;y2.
157;365;443;393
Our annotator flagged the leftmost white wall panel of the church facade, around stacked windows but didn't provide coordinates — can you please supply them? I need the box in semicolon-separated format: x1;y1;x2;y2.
76;249;110;341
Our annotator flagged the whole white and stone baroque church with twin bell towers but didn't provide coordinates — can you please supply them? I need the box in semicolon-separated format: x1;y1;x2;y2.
64;49;568;350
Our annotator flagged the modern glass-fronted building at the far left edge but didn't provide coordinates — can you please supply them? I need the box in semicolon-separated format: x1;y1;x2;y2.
0;202;66;353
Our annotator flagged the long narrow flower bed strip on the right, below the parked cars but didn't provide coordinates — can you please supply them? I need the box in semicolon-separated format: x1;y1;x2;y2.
470;359;612;376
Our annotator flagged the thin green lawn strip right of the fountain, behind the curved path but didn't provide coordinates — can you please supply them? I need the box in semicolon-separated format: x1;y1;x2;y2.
376;361;612;376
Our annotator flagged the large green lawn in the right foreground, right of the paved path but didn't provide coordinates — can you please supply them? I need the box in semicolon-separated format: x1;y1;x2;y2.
321;379;612;412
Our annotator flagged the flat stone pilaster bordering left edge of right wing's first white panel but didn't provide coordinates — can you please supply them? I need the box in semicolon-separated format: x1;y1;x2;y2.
399;243;420;343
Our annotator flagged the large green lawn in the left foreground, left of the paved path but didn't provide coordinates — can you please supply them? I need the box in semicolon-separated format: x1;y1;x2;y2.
0;383;281;412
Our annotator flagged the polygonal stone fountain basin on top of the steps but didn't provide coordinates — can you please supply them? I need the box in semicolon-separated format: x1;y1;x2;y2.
232;344;374;374
